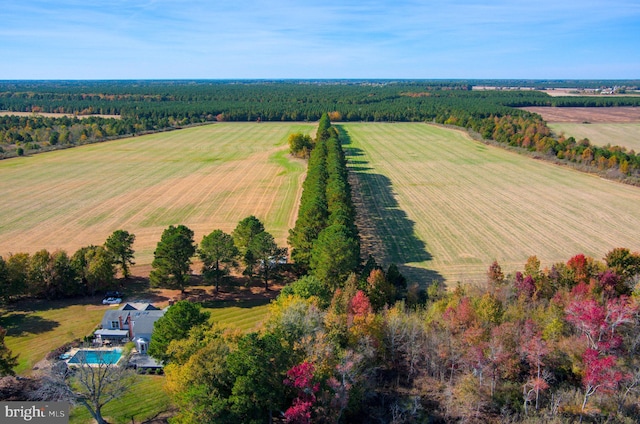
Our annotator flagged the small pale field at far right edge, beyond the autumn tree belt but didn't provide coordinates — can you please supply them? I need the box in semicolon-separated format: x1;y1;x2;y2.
548;122;640;152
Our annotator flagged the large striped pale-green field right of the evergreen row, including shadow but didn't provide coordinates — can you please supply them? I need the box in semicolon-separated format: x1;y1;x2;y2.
341;123;640;284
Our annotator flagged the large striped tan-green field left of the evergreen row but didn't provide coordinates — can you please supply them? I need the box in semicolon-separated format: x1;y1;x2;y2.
0;123;315;272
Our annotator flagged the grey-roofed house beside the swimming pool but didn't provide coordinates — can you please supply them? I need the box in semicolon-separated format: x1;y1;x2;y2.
95;303;166;353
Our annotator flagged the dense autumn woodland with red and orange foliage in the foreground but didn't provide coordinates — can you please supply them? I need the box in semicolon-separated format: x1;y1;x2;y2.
165;248;640;423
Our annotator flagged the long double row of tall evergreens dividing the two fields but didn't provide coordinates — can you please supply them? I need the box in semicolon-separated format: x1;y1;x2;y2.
288;114;360;288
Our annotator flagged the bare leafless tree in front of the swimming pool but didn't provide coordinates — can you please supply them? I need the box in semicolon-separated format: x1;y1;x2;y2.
32;350;136;424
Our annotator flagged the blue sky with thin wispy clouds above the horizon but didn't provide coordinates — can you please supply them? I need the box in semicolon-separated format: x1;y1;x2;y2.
0;0;640;80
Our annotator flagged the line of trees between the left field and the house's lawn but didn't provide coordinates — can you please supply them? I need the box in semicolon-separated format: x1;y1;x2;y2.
0;216;287;303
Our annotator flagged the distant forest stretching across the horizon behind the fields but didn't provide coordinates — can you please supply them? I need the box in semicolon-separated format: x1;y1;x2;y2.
0;80;640;184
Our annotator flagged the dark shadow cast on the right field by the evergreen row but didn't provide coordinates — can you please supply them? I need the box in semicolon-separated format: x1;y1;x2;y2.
336;125;444;287
